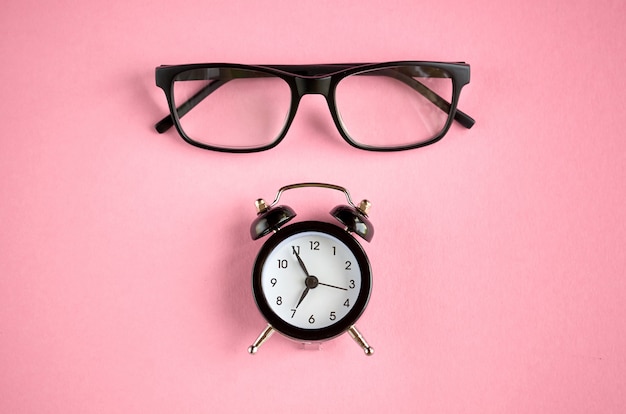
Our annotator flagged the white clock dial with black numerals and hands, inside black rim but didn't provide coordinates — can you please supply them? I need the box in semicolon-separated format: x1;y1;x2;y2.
260;231;362;329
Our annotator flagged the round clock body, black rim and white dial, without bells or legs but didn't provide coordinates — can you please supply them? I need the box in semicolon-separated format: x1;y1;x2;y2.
253;221;371;340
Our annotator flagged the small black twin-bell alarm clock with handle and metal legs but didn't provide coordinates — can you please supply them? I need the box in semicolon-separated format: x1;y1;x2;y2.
248;183;374;355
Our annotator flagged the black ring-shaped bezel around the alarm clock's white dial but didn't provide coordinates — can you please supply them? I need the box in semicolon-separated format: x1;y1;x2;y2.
252;221;372;342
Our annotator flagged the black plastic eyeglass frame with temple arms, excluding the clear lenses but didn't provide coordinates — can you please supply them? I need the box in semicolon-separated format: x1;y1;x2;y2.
155;61;475;153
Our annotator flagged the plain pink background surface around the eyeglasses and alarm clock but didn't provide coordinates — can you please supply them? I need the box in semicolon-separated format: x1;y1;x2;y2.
0;0;626;413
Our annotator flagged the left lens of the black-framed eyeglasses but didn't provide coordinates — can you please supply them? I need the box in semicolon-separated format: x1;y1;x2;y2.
173;68;291;149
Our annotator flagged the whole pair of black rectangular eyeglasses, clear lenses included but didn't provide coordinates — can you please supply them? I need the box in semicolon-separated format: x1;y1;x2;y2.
155;61;474;152
